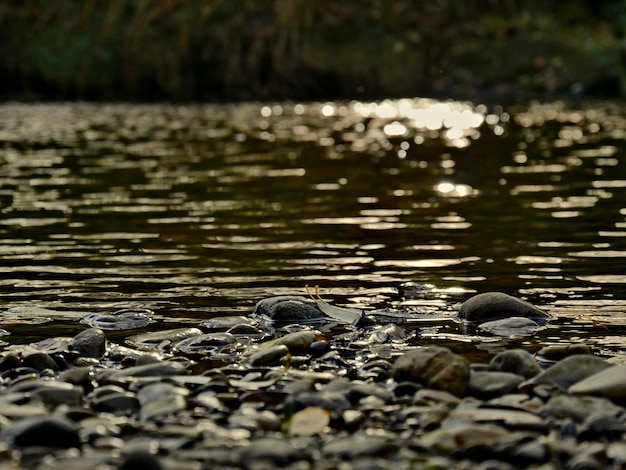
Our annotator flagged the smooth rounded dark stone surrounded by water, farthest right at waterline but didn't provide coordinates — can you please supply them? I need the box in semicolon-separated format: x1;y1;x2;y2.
459;292;550;322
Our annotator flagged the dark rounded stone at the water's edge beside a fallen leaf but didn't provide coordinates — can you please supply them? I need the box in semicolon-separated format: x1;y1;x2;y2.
252;295;329;323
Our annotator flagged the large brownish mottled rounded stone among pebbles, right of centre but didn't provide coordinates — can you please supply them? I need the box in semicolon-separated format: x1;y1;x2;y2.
392;346;470;395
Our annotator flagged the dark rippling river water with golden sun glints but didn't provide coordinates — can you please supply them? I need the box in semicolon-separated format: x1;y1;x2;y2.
0;99;626;360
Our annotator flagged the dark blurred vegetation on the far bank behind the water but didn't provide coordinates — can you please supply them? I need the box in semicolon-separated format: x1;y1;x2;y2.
0;0;626;101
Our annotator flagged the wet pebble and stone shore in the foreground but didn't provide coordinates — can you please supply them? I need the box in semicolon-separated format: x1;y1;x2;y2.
0;293;626;470
